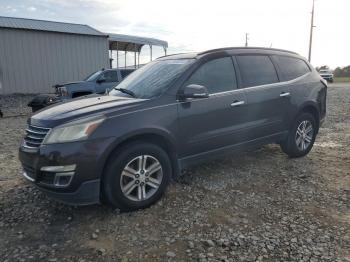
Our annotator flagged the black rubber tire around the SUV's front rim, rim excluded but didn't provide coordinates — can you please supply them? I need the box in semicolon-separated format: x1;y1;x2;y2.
102;141;172;211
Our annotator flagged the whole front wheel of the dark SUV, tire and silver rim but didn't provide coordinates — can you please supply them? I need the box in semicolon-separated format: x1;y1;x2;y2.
102;142;172;211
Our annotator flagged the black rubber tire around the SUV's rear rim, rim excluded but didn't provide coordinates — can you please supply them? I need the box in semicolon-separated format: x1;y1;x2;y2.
281;112;318;158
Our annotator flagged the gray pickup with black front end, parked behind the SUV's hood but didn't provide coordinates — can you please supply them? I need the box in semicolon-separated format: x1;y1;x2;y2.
28;69;135;112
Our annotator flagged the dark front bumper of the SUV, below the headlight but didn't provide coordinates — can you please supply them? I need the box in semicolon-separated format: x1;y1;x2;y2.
19;138;113;205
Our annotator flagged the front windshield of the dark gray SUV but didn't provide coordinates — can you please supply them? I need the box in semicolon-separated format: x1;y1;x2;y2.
110;59;193;99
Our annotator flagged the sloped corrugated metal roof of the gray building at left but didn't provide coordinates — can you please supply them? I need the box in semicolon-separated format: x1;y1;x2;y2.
0;16;106;36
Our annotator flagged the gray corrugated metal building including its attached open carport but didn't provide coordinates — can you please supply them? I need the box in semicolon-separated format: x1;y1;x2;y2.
0;16;168;95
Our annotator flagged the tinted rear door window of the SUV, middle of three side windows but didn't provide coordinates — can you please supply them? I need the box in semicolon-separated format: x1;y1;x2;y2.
236;55;279;87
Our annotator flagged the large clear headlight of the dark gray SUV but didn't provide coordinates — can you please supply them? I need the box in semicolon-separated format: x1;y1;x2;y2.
43;116;105;144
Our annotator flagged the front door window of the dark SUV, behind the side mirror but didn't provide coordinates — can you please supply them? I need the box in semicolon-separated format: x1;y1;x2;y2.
185;57;237;94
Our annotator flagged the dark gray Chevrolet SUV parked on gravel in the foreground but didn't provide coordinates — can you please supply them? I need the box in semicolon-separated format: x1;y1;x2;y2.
19;48;327;210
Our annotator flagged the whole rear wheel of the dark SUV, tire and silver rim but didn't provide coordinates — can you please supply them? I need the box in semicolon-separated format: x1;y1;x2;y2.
281;113;318;158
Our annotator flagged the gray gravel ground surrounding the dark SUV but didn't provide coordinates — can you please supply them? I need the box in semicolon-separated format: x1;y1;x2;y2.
0;84;350;262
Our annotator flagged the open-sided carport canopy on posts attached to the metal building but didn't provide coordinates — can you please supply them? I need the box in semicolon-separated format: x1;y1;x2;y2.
107;34;168;68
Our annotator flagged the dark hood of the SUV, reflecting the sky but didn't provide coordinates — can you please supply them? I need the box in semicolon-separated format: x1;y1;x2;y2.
29;95;147;127
